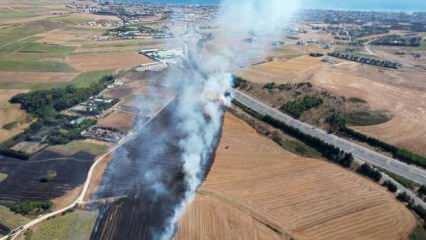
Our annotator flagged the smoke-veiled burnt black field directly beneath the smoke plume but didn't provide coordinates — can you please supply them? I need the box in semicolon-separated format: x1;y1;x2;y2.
91;101;223;240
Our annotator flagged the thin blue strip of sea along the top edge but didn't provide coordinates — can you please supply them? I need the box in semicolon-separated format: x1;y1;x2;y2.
142;0;426;11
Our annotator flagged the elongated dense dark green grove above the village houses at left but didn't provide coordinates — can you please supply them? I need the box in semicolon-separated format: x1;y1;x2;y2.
10;75;114;118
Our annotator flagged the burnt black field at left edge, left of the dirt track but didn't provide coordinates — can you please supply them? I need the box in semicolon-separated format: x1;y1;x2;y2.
0;151;95;201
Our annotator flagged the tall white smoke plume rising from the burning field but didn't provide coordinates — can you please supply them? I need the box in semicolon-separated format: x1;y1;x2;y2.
160;0;298;240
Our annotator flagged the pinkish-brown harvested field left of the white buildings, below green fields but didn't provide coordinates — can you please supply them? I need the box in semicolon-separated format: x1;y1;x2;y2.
66;52;151;72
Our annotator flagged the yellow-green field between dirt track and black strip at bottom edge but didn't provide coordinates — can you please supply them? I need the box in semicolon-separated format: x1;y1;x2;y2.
26;210;97;240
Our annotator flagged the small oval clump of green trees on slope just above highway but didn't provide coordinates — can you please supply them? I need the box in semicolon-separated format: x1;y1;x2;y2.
280;96;323;118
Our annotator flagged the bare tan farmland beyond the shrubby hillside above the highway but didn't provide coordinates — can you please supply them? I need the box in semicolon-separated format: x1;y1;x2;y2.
237;56;426;154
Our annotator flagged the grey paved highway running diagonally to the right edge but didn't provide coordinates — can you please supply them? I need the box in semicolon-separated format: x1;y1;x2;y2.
234;90;426;185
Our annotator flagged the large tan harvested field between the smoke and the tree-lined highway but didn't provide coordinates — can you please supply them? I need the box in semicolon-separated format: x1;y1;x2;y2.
177;115;416;240
